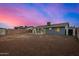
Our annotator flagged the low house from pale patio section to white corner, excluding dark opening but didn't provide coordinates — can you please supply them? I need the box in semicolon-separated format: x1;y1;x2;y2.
33;22;69;35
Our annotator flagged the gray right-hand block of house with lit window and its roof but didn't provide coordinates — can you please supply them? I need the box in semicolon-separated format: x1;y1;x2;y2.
46;23;69;35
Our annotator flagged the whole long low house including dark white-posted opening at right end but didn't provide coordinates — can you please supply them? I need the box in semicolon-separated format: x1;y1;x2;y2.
33;22;76;36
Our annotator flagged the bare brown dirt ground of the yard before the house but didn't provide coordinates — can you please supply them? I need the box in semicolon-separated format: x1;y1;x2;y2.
0;34;79;56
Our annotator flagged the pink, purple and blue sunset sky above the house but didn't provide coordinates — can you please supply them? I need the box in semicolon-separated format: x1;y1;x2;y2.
0;3;79;28
